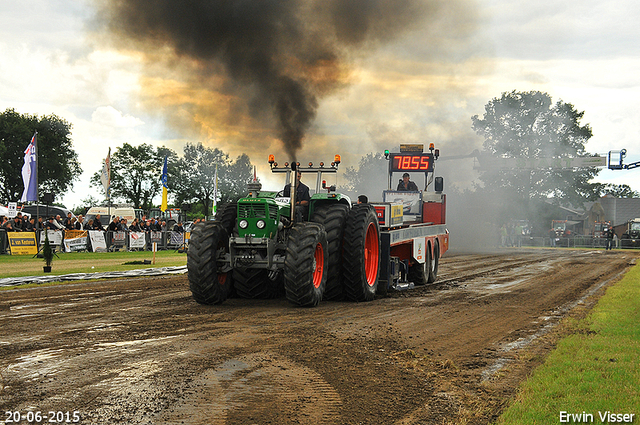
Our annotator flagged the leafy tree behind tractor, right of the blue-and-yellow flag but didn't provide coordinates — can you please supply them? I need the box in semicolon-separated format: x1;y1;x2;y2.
176;143;253;215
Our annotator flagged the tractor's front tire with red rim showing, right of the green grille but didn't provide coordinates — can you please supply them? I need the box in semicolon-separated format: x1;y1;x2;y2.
284;222;328;307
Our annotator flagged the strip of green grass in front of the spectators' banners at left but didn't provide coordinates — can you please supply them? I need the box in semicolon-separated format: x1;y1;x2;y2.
0;250;187;278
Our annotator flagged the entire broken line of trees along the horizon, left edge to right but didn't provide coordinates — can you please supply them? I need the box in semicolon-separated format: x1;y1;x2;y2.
0;90;640;219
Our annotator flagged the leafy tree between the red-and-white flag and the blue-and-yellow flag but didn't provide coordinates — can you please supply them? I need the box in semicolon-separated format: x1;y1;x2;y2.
91;143;177;210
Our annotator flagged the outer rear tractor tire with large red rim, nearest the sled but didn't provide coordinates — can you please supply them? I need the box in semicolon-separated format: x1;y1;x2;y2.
342;204;380;301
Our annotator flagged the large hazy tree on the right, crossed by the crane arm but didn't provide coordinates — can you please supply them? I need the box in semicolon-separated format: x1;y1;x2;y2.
472;90;599;205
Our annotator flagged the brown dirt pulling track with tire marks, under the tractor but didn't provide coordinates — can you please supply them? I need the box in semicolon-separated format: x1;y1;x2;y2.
0;250;638;424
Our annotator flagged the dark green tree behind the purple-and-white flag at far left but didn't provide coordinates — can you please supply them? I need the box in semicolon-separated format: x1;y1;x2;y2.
0;109;82;203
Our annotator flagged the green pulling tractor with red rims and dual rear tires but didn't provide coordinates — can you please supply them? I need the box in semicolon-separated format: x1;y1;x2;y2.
187;155;380;307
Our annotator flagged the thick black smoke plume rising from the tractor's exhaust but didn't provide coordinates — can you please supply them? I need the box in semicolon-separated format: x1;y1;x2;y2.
94;0;436;158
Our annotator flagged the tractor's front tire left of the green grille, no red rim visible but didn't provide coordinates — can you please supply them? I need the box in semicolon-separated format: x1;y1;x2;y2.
187;221;233;305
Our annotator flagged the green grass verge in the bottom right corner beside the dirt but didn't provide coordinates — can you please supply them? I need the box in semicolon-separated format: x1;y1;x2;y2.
497;265;640;425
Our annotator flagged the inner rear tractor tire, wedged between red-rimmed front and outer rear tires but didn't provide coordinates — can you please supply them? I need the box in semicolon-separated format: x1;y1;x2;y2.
310;203;349;300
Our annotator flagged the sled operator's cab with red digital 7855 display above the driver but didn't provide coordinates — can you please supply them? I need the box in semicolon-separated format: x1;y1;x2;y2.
375;143;446;227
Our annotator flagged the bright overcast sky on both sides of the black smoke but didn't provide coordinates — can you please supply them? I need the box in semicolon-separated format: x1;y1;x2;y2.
0;0;640;208
